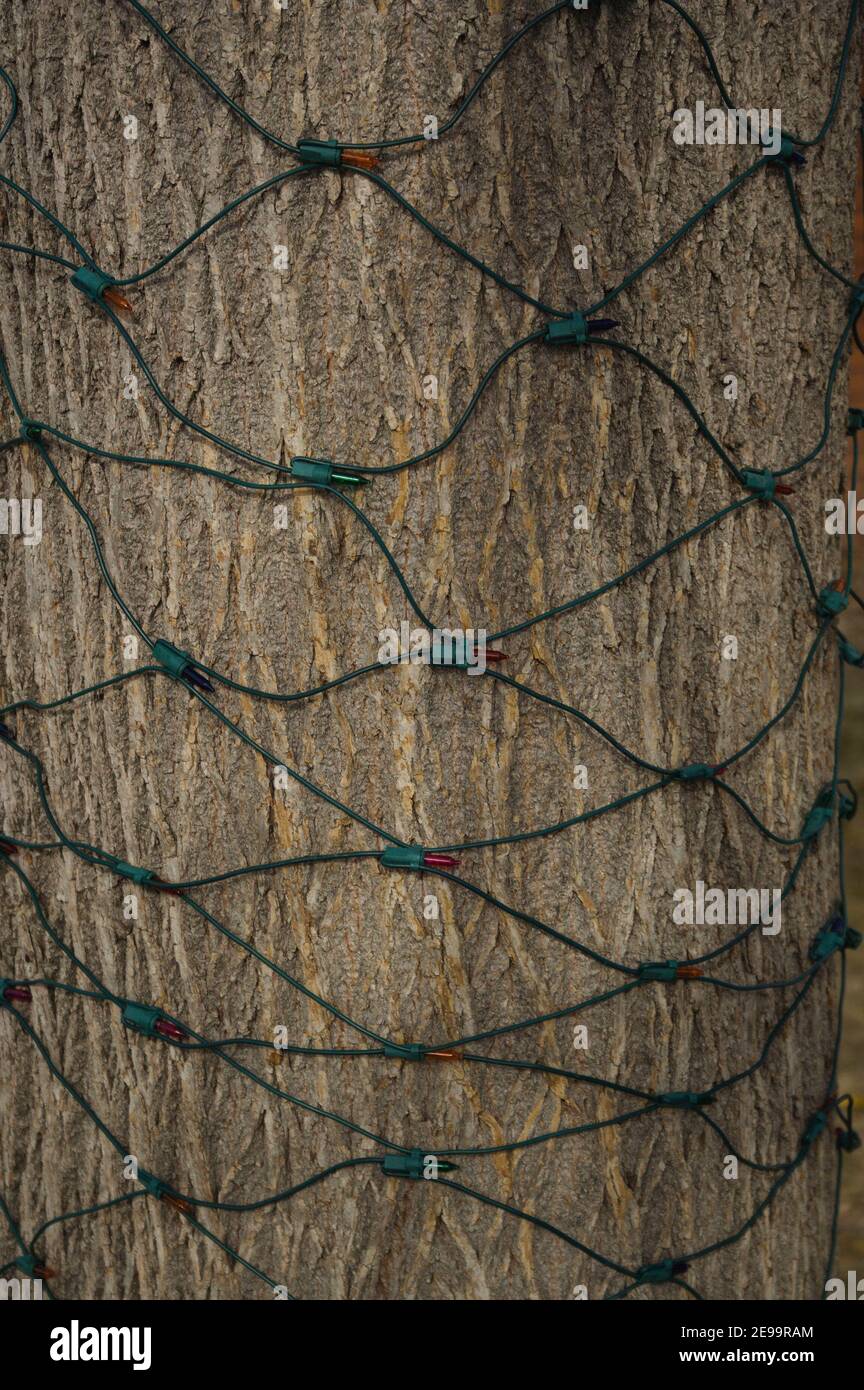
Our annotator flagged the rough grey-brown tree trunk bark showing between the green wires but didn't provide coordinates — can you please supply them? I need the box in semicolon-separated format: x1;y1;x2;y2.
0;0;858;1300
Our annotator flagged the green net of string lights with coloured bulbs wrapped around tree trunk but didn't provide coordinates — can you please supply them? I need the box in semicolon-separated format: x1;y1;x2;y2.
0;0;864;1300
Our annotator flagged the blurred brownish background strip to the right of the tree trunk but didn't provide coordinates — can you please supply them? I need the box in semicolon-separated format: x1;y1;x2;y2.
835;138;864;1277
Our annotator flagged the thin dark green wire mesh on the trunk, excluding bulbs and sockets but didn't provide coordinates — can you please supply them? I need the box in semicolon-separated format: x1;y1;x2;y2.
0;0;864;1300
